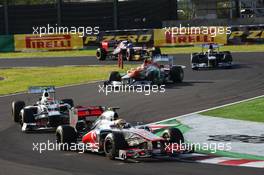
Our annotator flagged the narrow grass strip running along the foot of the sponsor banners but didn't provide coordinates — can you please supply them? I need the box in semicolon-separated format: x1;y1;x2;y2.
0;45;264;59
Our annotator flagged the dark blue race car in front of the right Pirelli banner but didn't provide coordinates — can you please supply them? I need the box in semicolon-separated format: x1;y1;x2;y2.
191;44;233;70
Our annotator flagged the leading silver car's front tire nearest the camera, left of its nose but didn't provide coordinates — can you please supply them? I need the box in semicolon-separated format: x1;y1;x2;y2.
104;132;128;160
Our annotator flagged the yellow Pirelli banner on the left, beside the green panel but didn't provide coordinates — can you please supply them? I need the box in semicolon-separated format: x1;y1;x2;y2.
14;34;83;51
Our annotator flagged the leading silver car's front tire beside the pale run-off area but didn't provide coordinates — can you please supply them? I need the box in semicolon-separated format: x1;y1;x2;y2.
162;128;184;144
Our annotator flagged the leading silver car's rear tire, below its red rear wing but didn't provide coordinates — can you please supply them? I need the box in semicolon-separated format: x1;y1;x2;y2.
56;125;77;151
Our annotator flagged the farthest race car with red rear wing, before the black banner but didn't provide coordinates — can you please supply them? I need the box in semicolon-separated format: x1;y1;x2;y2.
96;40;161;61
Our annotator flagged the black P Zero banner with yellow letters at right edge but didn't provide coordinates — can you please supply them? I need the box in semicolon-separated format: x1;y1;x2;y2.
228;25;264;45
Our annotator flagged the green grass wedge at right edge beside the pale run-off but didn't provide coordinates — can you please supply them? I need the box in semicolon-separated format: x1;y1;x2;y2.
201;97;264;122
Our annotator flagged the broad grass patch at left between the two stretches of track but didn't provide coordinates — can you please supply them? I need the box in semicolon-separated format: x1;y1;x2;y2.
0;65;137;95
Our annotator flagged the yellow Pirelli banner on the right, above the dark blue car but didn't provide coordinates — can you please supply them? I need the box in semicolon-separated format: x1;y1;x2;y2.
154;27;227;46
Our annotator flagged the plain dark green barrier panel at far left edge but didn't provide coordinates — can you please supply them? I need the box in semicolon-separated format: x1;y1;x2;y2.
0;35;15;52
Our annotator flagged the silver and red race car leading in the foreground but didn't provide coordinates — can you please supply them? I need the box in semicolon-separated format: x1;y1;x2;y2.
56;109;188;160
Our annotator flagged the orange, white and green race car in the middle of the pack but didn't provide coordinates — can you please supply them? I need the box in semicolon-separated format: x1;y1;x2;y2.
104;55;185;86
